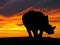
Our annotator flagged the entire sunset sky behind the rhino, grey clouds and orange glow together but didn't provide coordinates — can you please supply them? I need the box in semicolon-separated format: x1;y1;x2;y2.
0;0;60;38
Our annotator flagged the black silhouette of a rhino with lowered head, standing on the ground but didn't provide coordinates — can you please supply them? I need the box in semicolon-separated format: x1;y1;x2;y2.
22;10;56;37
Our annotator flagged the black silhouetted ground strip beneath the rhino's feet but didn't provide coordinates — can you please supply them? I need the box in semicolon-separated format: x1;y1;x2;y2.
0;37;60;45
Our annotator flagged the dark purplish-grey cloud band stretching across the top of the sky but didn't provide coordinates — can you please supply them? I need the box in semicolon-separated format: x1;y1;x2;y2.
0;0;60;16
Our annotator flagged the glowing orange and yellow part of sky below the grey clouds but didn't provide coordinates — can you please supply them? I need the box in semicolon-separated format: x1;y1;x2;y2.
0;8;60;38
